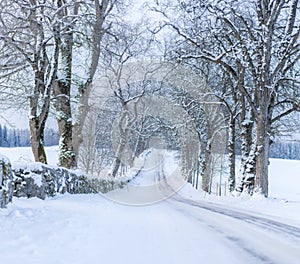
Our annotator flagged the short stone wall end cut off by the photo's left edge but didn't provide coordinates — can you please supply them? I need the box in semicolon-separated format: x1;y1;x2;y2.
0;155;13;208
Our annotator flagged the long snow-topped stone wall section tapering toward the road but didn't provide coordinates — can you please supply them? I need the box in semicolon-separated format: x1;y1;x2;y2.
13;163;125;199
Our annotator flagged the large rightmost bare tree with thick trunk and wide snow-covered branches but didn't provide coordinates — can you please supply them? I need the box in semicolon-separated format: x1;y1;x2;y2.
155;0;300;196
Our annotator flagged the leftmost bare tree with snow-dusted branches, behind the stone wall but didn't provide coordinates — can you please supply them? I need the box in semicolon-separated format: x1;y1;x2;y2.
0;0;58;163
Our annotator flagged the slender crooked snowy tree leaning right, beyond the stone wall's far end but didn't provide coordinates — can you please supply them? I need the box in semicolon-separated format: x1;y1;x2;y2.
103;23;157;177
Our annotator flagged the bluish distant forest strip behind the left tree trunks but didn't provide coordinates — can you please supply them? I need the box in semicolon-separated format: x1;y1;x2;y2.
0;125;59;148
